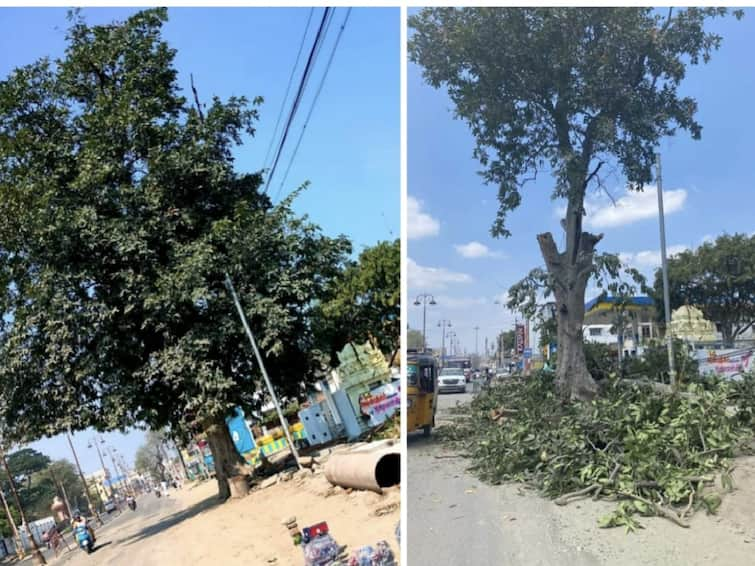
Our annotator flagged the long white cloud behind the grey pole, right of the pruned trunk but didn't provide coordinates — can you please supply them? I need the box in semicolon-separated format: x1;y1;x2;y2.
585;186;687;228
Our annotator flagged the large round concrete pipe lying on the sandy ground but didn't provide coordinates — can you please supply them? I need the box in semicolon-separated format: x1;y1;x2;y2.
325;442;401;493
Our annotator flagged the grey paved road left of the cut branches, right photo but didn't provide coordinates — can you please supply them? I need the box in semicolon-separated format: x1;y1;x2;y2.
407;386;598;566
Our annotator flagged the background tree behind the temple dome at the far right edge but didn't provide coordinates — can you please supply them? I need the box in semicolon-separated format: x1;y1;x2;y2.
653;234;755;346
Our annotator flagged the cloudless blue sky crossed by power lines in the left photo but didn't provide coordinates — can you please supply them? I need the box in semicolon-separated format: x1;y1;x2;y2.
0;8;400;472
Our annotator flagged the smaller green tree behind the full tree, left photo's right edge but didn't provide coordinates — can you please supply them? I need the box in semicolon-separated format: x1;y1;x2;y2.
320;239;401;365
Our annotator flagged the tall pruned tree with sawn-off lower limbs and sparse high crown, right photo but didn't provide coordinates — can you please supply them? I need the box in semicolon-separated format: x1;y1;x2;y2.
409;8;739;398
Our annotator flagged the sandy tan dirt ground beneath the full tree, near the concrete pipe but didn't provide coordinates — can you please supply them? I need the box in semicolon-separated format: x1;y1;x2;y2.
57;474;400;566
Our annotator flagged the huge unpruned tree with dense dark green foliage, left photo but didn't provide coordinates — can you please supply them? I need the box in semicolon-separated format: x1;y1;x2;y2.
0;9;351;498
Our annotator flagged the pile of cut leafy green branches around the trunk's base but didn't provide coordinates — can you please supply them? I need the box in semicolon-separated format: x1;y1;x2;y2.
439;373;753;530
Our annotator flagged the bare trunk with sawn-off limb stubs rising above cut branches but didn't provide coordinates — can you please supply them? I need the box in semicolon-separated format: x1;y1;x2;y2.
537;232;600;400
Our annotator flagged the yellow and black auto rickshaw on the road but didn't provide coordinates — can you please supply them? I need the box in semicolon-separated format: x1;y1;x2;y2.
406;352;438;436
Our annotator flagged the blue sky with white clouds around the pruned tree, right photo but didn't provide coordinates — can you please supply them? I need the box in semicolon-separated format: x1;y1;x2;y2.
407;10;755;360
